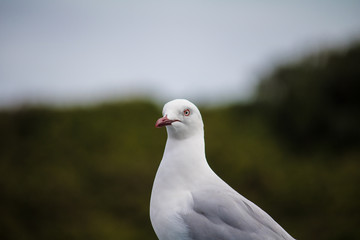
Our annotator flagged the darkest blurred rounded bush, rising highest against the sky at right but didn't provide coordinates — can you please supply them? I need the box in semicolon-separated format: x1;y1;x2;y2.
258;42;360;151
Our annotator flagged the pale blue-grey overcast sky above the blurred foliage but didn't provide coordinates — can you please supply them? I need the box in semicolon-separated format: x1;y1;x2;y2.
0;0;360;106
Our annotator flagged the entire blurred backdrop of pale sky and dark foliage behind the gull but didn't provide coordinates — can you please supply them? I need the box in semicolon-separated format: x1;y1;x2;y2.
0;0;360;240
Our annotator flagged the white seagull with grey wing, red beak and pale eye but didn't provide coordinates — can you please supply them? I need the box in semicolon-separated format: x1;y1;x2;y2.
150;99;294;240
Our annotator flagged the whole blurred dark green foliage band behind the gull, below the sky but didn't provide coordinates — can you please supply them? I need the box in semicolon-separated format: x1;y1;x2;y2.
0;42;360;240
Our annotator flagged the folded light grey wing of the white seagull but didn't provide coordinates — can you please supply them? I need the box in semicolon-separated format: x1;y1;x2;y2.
182;190;294;240
